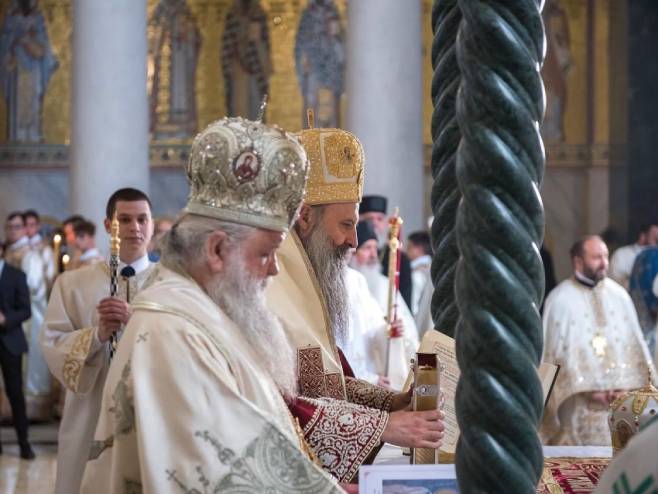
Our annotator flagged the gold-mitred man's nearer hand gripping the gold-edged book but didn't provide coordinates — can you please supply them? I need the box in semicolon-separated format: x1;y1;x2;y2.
382;410;445;449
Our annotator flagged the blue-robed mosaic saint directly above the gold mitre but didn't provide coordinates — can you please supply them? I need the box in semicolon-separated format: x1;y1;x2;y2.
295;0;346;127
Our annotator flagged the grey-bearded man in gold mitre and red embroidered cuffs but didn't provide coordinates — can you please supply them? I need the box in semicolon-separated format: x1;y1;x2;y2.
266;119;444;482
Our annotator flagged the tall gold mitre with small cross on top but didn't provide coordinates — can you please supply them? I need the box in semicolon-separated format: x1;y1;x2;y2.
295;110;365;205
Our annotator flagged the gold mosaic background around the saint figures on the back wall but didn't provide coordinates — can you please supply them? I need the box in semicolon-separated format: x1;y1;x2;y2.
0;0;612;151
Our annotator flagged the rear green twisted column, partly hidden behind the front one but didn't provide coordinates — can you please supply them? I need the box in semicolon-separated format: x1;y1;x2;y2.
431;0;461;336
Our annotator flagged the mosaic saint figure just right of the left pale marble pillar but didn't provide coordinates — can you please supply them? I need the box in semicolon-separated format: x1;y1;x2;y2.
149;0;201;140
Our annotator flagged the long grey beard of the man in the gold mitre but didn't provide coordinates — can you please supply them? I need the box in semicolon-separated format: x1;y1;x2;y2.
302;223;350;348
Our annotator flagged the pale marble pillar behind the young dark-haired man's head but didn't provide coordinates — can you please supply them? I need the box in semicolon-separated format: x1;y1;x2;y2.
69;0;149;248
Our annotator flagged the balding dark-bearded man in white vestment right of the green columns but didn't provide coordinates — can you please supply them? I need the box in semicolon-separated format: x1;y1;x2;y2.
541;236;655;446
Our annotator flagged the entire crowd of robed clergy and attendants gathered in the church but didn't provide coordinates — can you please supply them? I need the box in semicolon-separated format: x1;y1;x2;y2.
0;118;658;494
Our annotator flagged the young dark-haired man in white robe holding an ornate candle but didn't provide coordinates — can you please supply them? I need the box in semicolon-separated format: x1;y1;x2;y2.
40;188;154;494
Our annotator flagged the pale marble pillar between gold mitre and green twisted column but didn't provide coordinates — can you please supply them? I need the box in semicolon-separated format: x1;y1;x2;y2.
346;0;427;234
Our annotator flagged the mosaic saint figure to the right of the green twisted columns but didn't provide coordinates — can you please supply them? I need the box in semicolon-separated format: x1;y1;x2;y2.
541;0;572;142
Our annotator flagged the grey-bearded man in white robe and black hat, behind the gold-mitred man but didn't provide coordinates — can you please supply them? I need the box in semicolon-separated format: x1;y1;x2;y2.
343;221;418;391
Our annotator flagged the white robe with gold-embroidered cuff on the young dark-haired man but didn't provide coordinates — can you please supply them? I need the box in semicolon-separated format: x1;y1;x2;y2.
40;263;155;494
